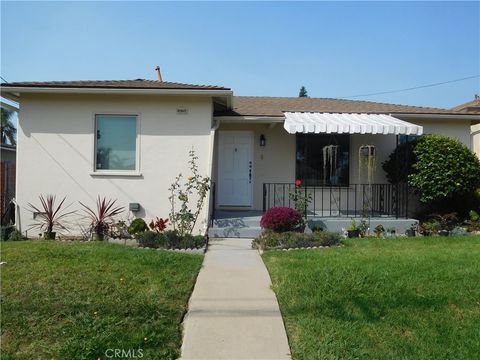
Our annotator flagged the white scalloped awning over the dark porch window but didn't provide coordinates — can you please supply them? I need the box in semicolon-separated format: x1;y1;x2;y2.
283;112;423;135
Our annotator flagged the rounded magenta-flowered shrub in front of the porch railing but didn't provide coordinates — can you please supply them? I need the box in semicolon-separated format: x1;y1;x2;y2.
260;207;305;232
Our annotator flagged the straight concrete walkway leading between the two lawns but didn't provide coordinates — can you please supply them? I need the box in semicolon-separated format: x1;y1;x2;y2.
182;239;290;360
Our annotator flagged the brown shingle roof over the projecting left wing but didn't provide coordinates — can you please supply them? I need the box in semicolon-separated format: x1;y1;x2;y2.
2;79;230;90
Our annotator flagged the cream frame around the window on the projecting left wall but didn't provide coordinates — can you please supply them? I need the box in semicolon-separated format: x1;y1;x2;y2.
90;111;142;176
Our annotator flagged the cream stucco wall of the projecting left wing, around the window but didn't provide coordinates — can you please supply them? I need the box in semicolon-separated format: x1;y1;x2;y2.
17;94;212;236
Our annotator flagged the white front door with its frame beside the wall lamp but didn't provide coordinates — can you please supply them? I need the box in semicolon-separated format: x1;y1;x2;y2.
217;131;253;206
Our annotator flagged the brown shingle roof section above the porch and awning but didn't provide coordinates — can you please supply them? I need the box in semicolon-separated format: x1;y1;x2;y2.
216;96;454;116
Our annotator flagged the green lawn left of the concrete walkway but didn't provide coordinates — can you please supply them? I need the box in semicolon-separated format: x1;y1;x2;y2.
1;241;203;359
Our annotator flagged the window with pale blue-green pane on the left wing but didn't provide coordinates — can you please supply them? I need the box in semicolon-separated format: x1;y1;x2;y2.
95;114;137;171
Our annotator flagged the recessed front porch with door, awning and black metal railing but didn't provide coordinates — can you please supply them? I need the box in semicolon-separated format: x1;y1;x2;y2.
210;113;423;237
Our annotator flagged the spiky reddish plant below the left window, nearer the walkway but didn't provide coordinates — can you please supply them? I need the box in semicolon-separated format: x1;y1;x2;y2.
80;196;124;240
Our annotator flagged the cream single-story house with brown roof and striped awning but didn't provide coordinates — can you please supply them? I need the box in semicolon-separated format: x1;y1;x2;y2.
1;79;480;236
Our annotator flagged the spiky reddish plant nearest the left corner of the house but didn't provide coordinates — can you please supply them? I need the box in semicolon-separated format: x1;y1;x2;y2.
28;195;75;240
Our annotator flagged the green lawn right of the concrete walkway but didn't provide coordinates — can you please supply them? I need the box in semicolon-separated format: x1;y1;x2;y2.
263;237;480;360
